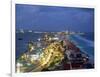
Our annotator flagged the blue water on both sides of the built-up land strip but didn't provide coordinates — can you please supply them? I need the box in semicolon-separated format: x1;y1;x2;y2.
16;32;94;62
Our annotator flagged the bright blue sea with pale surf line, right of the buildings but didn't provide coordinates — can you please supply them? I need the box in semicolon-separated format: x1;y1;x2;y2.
70;33;94;63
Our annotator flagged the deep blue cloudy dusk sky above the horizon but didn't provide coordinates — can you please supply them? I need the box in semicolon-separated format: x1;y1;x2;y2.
16;4;94;32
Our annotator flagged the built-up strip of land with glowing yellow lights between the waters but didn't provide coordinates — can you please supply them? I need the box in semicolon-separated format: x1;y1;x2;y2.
15;30;94;73
